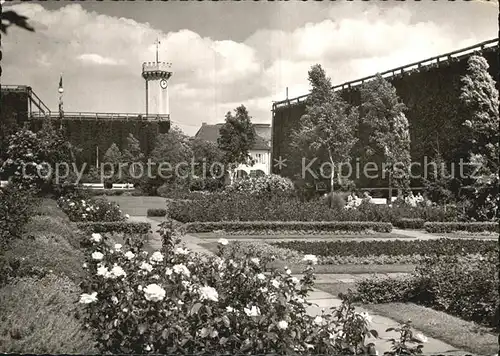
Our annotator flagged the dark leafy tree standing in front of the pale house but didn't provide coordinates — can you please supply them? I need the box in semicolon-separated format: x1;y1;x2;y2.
217;105;256;178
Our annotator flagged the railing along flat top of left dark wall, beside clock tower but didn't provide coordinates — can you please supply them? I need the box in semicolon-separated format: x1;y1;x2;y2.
30;112;170;121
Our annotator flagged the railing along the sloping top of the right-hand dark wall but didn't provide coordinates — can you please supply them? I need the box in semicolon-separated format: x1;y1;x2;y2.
273;38;499;110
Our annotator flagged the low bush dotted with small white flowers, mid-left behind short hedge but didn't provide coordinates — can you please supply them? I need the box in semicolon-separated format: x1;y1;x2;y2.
58;197;125;222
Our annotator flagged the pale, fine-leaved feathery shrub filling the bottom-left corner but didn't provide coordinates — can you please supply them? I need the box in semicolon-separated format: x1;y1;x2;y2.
0;274;96;355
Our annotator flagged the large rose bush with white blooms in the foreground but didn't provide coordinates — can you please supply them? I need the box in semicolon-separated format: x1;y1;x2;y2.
76;225;424;355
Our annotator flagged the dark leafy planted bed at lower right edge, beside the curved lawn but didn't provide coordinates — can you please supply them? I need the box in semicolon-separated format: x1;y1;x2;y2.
353;250;500;330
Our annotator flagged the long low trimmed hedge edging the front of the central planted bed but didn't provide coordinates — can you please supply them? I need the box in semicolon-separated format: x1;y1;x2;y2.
186;221;392;232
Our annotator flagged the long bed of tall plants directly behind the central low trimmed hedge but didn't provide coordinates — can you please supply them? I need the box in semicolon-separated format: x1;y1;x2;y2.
169;192;457;223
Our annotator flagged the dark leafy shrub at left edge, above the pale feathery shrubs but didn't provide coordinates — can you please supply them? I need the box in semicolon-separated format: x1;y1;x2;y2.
0;184;38;250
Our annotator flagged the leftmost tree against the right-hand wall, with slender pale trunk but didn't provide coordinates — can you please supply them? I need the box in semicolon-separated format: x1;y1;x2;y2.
292;64;358;203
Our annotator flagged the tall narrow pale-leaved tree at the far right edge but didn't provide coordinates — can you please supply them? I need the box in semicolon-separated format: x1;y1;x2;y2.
460;56;500;220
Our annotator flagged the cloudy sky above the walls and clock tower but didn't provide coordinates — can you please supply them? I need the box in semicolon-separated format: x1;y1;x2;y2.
1;0;498;135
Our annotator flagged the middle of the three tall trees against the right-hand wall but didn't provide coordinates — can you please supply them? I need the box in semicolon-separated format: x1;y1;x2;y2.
360;75;411;203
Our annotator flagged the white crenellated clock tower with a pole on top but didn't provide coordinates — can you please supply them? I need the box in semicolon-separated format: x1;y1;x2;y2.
142;40;172;116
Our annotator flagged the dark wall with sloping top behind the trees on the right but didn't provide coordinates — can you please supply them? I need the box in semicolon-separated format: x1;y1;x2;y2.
272;47;499;191
